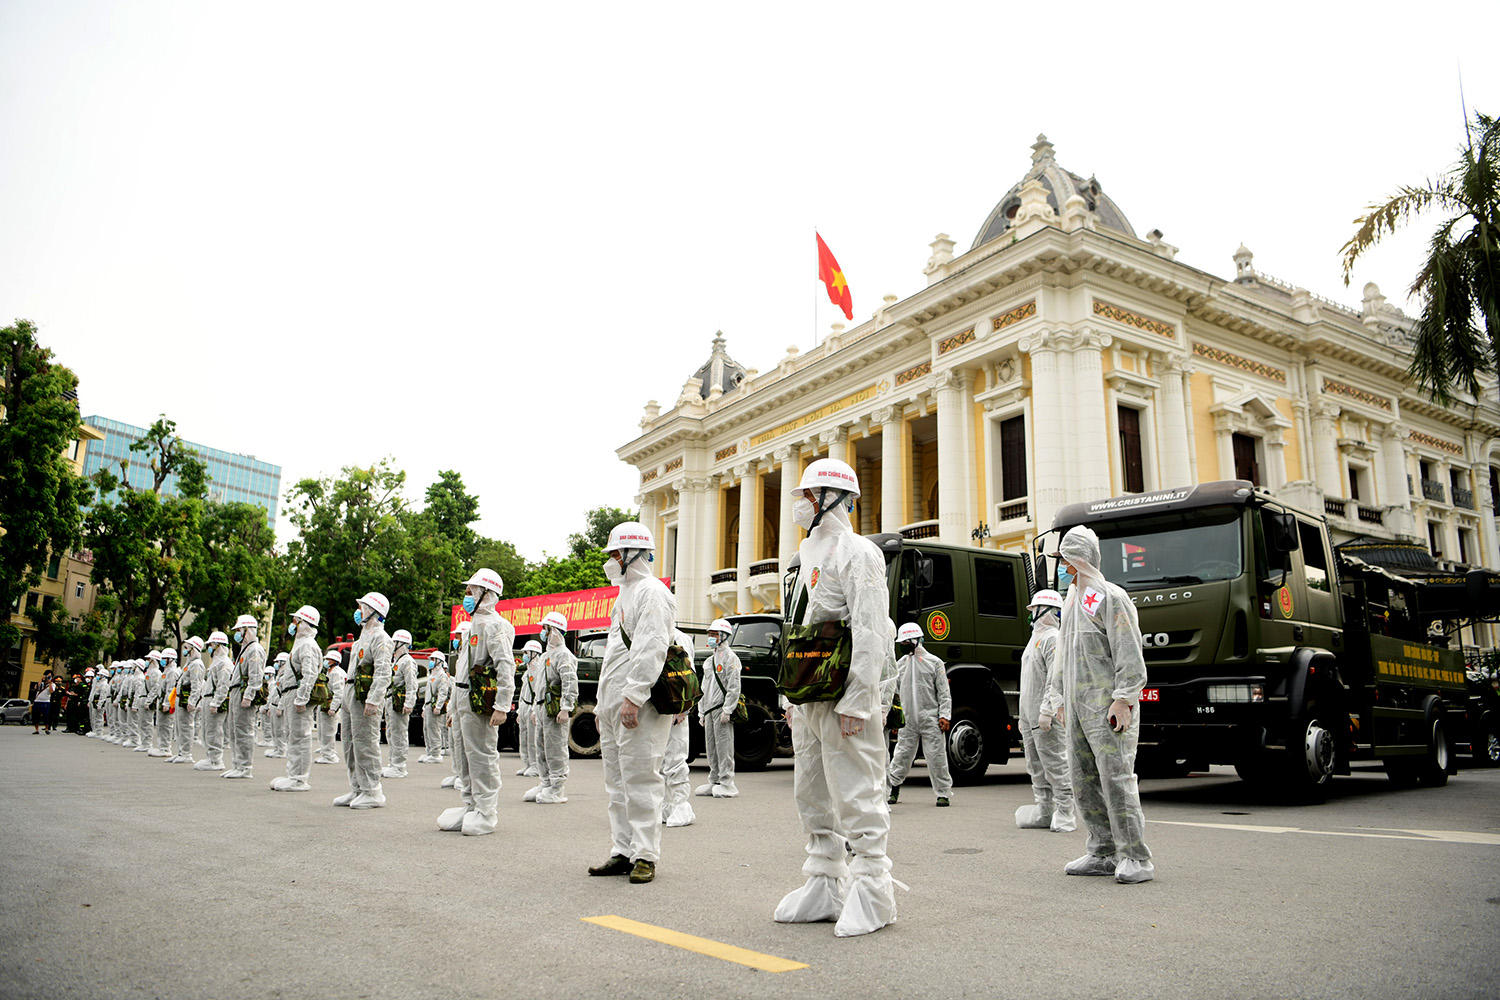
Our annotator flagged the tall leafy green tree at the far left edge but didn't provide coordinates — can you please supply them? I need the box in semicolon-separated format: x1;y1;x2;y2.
0;319;89;649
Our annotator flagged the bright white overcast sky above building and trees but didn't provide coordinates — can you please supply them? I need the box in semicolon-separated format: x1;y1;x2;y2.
0;0;1500;558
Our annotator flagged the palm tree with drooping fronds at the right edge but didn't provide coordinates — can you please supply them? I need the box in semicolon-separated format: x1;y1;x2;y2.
1344;114;1500;405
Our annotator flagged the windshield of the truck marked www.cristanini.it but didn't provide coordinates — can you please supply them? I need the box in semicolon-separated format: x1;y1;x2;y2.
1092;507;1244;591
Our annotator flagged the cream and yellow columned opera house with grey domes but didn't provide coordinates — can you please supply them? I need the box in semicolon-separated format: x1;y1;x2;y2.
617;136;1500;645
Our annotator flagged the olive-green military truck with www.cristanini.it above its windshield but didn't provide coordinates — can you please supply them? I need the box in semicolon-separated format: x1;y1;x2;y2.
1035;480;1467;801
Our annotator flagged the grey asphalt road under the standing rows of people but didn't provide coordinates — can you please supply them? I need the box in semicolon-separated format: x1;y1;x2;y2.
0;727;1500;1000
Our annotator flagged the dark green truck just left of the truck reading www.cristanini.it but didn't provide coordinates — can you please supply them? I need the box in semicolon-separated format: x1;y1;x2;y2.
783;532;1032;784
